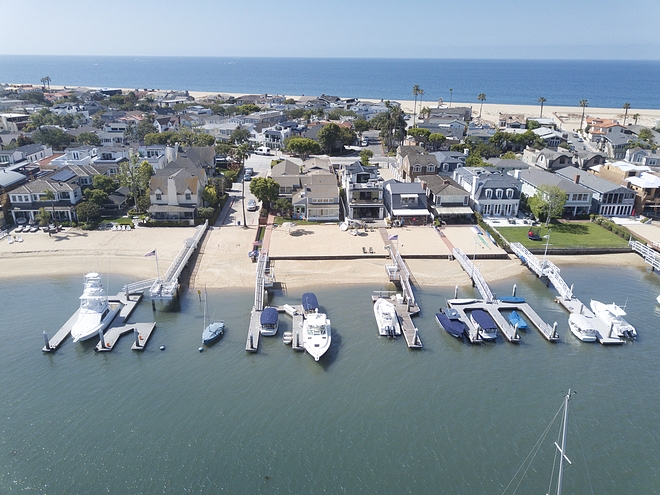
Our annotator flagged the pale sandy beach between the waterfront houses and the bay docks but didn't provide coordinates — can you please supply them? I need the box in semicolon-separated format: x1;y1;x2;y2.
0;225;648;289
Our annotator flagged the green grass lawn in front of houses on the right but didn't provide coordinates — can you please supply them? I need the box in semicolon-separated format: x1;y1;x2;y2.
497;222;628;249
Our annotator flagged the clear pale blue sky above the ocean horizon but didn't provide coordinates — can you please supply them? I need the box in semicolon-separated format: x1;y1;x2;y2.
5;0;660;60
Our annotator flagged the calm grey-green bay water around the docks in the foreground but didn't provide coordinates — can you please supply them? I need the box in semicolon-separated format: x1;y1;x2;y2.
0;266;660;494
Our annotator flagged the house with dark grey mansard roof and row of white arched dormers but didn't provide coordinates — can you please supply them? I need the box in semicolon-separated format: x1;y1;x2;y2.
453;167;522;217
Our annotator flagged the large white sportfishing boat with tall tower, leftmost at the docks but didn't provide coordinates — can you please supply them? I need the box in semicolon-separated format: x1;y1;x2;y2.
71;272;120;342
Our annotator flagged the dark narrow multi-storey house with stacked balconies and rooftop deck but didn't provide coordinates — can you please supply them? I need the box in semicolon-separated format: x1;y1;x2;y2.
340;161;385;220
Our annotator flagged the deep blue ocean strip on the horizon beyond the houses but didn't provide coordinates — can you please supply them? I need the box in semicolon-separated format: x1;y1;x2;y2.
0;55;660;113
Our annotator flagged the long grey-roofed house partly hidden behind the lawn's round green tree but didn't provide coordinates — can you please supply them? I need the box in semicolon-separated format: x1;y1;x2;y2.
512;168;592;217
